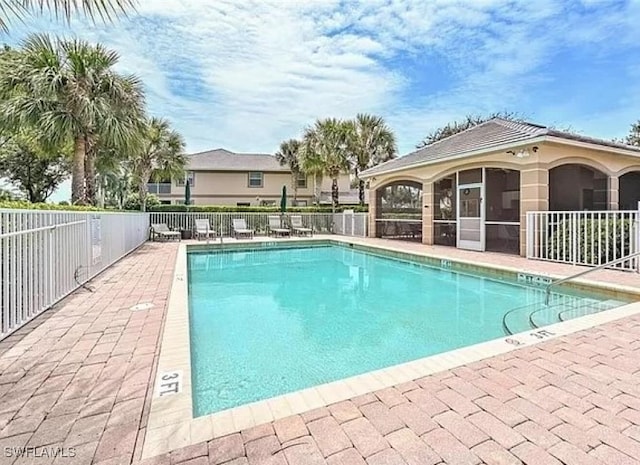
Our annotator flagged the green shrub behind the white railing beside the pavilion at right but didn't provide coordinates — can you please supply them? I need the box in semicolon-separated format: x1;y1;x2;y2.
547;218;633;264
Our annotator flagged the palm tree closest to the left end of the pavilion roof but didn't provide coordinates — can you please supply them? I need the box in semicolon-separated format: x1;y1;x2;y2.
349;113;398;205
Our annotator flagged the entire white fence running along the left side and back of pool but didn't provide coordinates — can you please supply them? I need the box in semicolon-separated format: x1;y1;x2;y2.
0;210;368;340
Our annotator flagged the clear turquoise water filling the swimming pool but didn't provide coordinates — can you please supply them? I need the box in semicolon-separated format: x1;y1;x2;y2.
188;246;624;416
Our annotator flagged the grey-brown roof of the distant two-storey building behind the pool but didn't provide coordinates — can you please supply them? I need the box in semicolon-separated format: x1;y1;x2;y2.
188;149;289;172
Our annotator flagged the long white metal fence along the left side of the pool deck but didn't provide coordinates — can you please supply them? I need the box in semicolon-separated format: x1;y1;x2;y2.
0;210;149;340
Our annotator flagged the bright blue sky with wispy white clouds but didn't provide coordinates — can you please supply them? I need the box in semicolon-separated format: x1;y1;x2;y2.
4;0;640;200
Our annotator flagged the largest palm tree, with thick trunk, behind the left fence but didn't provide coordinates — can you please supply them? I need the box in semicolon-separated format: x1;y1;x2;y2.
0;35;144;204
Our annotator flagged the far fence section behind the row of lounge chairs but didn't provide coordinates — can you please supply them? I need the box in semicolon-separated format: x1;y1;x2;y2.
150;211;368;237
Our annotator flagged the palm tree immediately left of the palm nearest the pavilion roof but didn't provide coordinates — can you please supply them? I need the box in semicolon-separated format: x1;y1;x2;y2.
303;118;353;209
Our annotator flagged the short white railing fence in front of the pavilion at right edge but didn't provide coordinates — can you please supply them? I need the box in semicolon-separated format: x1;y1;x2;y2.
526;210;640;271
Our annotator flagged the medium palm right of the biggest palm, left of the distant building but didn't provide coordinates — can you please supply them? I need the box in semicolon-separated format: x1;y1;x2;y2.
129;118;187;211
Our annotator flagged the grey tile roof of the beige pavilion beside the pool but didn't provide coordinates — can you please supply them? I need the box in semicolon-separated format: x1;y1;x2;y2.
361;118;640;177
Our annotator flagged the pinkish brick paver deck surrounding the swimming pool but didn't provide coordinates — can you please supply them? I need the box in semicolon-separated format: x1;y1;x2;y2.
0;238;640;465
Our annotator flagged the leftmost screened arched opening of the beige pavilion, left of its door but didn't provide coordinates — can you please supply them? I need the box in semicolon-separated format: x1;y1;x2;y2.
376;180;422;242
